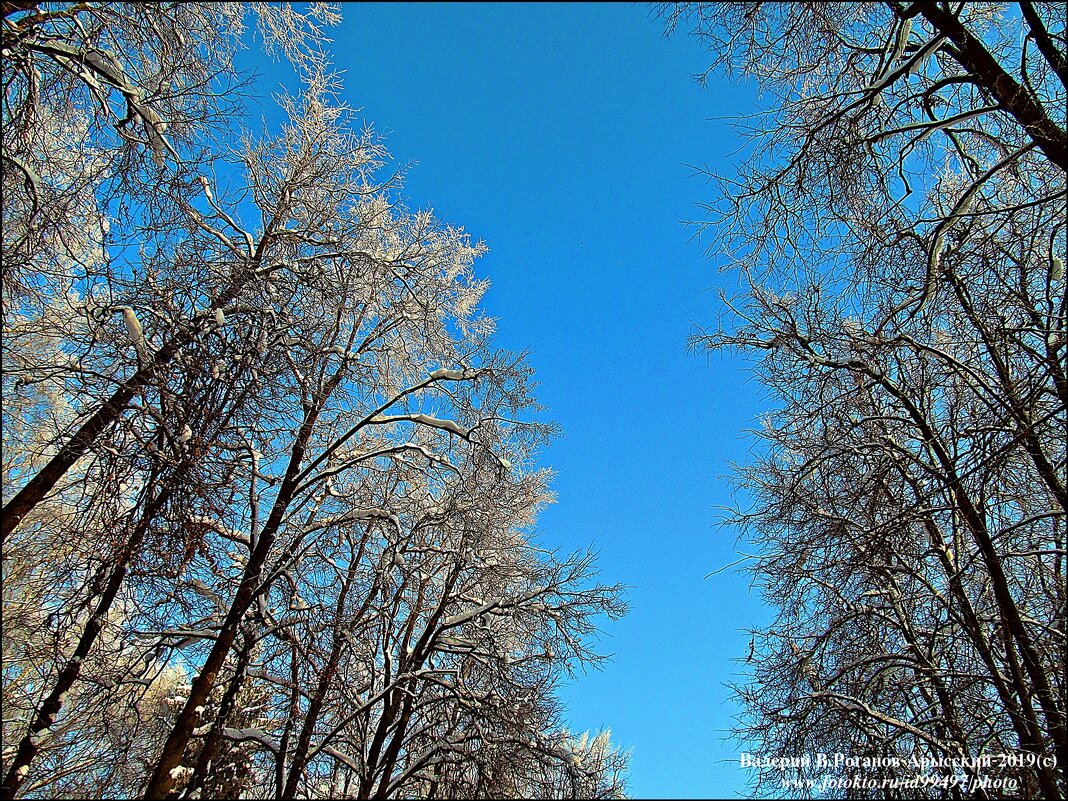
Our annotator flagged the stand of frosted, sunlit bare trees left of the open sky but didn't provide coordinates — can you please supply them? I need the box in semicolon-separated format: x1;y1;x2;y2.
3;3;625;798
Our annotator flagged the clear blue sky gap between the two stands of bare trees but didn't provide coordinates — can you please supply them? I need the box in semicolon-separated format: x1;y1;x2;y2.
246;3;767;798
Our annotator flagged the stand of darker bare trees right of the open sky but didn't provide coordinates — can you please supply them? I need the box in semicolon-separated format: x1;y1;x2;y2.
664;2;1068;798
